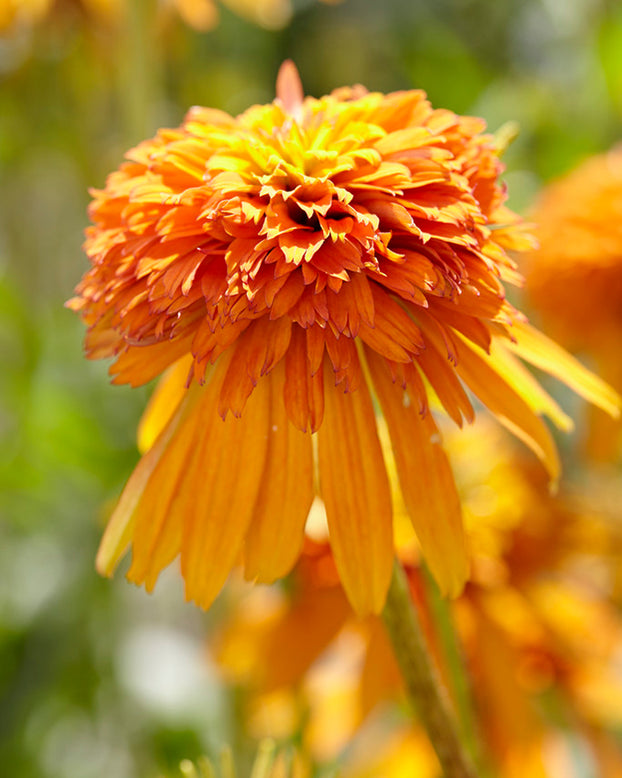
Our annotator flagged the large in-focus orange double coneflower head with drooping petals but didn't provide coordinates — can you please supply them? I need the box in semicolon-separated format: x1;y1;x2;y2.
69;62;619;613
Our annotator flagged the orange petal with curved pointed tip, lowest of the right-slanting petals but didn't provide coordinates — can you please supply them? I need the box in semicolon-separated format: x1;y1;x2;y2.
456;340;560;485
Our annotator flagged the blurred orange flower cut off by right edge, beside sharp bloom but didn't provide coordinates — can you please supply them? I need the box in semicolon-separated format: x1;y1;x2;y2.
525;148;622;458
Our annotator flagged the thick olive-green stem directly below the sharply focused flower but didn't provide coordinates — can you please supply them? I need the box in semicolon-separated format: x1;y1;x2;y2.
382;560;477;778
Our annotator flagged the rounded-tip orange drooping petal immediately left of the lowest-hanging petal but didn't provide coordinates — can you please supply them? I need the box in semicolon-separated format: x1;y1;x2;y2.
244;365;314;583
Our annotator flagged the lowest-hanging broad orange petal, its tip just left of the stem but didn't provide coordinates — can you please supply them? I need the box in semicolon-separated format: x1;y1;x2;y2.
317;354;393;614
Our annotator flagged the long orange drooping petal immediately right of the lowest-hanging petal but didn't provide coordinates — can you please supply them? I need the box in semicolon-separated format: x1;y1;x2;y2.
365;349;469;597
